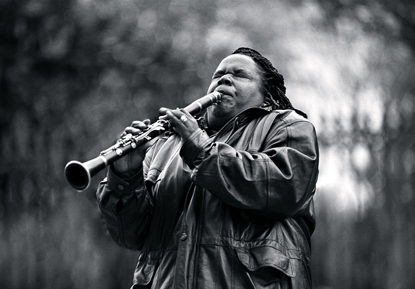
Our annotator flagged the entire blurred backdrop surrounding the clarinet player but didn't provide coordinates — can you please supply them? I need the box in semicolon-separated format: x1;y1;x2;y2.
0;0;415;289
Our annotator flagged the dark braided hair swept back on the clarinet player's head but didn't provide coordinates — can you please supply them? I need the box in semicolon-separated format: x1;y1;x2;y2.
232;47;307;118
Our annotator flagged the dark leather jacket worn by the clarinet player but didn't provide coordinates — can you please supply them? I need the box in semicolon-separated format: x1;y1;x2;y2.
97;108;319;289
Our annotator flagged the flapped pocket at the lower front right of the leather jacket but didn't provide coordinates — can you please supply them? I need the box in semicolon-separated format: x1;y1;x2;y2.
236;246;296;288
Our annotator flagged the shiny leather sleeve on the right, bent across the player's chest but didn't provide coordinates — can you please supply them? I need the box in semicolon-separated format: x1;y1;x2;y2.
181;113;318;218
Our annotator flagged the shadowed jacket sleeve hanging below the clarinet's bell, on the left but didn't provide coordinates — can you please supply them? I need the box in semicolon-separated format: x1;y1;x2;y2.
96;148;153;250
